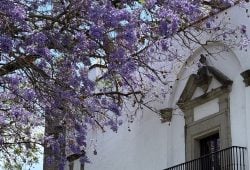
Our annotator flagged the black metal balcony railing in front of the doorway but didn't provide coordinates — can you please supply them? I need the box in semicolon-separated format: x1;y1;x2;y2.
165;146;247;170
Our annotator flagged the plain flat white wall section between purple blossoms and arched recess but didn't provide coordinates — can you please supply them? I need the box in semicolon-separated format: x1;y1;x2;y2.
85;111;170;170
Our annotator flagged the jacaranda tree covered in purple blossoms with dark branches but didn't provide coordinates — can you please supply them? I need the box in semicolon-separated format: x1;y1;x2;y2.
0;0;249;169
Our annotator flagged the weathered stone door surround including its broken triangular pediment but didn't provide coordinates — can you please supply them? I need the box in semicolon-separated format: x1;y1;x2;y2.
177;65;233;161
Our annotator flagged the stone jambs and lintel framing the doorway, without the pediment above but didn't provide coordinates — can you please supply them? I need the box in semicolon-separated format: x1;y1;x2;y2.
185;91;231;161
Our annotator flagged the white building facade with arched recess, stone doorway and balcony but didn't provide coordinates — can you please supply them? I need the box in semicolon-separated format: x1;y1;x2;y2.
66;2;250;170
